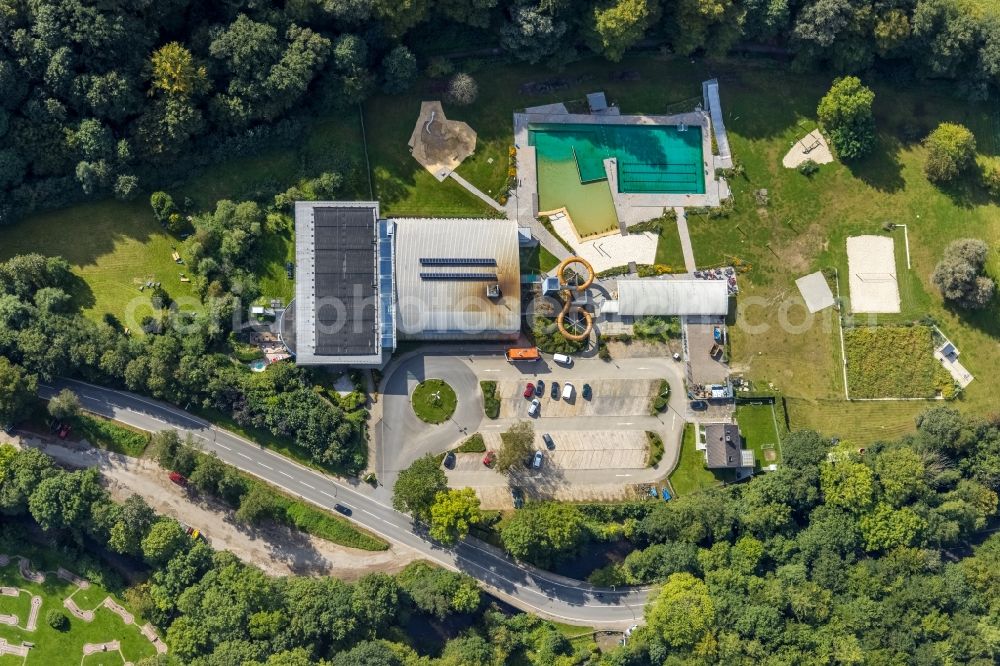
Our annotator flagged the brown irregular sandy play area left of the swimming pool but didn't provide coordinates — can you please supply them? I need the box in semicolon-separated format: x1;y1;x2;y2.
409;102;476;181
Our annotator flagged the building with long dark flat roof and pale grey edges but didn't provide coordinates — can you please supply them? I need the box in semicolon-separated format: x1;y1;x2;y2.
281;201;396;366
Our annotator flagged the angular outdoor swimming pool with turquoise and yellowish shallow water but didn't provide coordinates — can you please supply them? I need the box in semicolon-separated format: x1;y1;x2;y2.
528;124;705;236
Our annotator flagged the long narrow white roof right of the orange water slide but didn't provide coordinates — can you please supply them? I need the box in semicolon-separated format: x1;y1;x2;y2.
618;279;729;317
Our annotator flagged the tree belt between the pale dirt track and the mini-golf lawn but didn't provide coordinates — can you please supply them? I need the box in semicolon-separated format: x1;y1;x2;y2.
0;438;590;666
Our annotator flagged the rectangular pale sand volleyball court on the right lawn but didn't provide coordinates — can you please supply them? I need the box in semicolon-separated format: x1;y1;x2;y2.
847;236;899;313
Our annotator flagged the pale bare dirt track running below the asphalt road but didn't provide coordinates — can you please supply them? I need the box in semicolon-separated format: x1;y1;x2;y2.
7;439;418;580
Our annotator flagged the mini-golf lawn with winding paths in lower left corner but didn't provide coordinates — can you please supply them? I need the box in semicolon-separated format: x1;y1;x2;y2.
0;543;156;666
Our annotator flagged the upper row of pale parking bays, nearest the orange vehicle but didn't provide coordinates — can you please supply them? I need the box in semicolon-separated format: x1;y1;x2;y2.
497;377;660;418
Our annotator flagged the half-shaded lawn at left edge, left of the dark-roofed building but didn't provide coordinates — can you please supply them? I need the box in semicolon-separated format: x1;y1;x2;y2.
0;198;201;324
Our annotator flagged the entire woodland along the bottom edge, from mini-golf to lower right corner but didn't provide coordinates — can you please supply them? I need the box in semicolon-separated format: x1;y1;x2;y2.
0;408;1000;666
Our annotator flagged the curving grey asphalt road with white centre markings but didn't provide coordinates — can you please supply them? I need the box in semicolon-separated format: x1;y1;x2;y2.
39;373;651;629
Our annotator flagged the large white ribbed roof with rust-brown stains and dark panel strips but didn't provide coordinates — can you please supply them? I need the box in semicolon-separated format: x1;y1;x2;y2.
390;218;521;340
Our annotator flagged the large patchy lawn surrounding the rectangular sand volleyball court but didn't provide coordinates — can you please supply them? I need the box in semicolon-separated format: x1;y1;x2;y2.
688;64;1000;442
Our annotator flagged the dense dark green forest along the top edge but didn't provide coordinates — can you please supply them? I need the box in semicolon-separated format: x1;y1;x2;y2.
0;0;1000;224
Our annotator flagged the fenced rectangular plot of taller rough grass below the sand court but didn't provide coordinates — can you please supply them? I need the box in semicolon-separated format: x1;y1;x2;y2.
844;326;953;398
